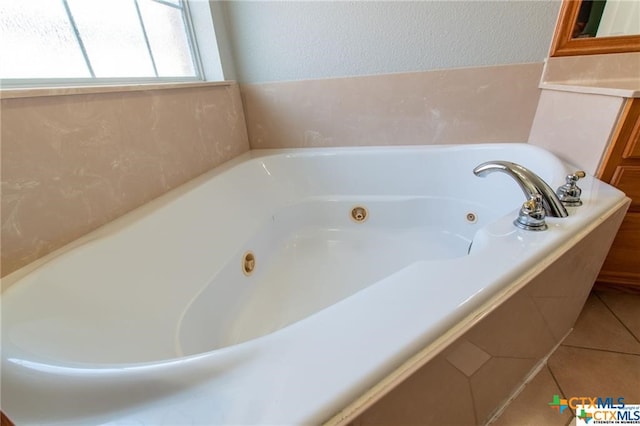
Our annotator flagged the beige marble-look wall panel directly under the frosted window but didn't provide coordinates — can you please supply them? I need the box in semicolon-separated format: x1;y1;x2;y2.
0;84;249;276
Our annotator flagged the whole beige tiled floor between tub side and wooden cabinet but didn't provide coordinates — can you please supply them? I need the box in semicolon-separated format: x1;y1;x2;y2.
491;288;640;426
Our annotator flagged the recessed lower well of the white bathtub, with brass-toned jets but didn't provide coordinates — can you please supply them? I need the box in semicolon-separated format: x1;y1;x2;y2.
178;196;500;355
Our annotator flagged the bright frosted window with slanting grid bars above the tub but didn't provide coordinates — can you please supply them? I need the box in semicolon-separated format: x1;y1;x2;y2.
0;0;202;87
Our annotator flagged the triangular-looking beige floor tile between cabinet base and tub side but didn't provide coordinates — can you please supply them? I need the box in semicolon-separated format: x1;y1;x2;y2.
563;294;640;355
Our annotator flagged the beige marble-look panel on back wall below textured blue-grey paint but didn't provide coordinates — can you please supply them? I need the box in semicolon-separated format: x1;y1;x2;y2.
240;63;542;149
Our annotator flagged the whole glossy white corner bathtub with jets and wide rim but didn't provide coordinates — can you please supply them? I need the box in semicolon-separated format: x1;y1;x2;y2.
2;144;628;425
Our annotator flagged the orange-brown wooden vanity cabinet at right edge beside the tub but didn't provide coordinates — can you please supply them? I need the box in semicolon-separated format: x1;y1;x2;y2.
598;98;640;291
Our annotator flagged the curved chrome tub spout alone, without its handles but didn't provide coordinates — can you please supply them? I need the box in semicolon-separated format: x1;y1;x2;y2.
473;161;569;217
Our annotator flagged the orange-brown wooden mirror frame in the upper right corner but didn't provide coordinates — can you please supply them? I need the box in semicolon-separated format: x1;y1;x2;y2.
549;0;640;57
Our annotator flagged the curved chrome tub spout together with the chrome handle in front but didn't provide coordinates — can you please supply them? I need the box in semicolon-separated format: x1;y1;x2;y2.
473;161;569;231
